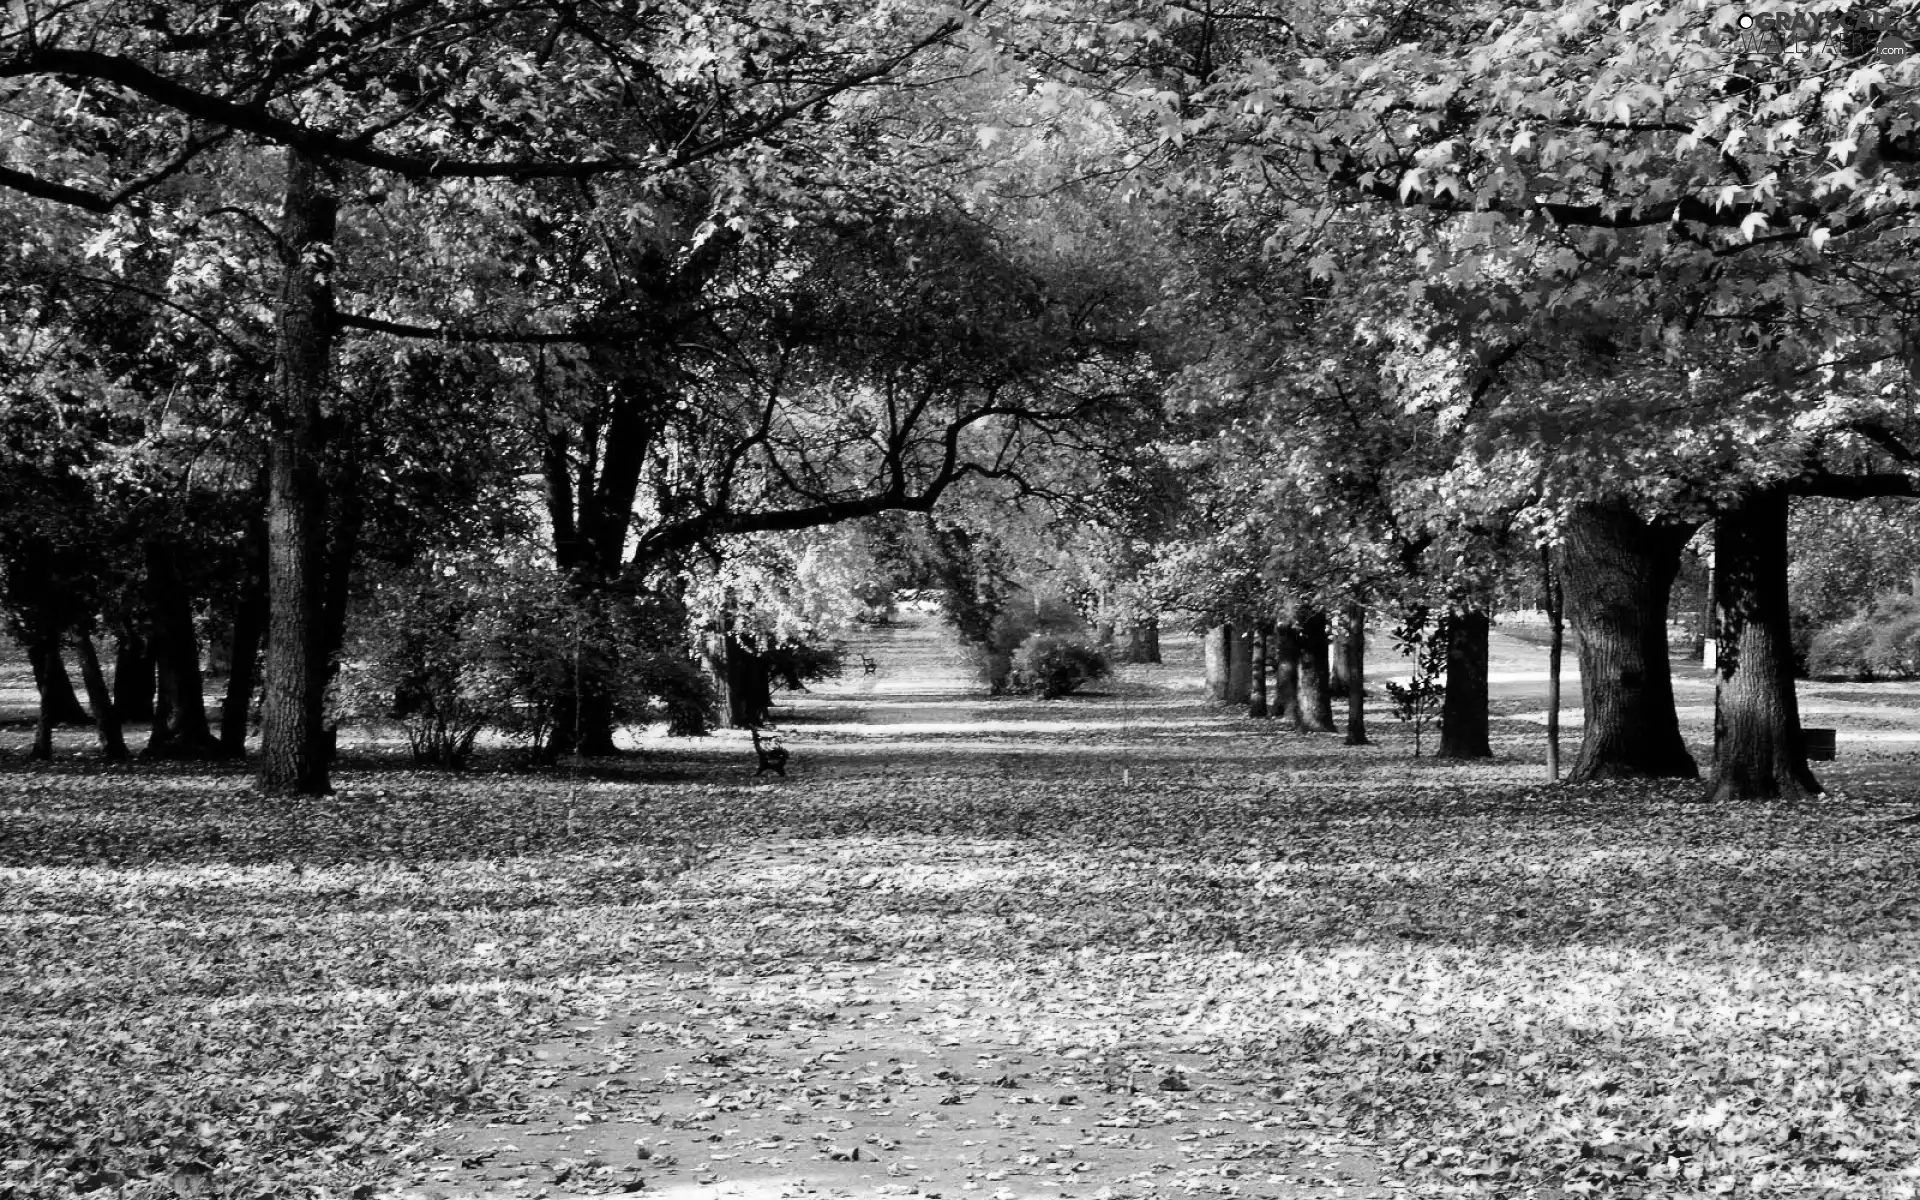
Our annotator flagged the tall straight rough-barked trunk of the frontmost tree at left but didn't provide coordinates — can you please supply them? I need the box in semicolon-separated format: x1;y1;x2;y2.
257;150;338;795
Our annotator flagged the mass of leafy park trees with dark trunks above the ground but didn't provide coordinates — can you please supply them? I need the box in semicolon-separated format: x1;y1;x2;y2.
0;0;1920;797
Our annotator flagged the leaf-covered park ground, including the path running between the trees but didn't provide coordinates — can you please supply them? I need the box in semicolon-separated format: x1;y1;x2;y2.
0;624;1920;1200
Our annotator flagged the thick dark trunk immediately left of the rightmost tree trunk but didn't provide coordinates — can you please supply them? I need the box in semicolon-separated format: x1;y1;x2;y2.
1561;503;1699;783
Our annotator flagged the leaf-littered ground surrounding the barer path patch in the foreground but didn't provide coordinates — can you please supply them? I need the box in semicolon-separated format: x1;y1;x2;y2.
0;622;1920;1200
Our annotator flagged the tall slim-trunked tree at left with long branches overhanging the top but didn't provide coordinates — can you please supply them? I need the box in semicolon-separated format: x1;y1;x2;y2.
0;0;990;791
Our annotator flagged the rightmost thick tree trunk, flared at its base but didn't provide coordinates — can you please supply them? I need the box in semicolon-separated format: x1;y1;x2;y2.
1709;492;1822;801
